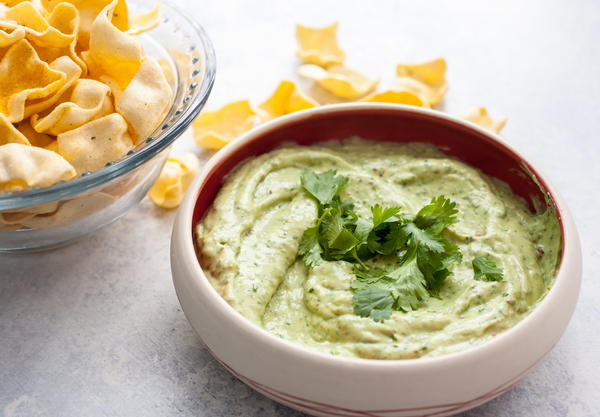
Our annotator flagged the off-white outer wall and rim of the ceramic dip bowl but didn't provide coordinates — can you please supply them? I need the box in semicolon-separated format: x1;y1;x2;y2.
171;104;581;417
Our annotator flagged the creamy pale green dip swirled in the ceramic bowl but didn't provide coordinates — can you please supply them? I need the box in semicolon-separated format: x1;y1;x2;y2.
196;138;561;359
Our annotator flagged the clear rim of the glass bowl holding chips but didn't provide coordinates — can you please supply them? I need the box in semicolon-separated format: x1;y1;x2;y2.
0;0;216;211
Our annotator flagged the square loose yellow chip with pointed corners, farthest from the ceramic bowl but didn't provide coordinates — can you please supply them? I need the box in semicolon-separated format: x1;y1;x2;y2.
296;23;345;67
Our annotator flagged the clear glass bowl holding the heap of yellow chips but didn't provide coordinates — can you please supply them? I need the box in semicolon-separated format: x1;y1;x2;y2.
0;0;216;252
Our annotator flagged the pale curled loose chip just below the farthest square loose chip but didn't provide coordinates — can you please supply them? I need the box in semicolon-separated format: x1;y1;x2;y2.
298;64;379;99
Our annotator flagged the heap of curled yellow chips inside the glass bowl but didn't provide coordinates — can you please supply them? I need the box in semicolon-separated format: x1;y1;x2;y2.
0;0;173;193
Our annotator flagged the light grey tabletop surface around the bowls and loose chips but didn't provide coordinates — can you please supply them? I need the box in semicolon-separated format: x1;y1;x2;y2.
0;0;600;417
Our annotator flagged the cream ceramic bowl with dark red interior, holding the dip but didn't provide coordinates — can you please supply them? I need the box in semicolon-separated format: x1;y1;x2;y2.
171;103;581;417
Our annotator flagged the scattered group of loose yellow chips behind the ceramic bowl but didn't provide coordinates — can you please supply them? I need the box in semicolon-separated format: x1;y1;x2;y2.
194;23;506;150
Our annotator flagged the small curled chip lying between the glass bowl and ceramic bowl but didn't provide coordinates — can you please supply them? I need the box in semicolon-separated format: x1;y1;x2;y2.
148;153;200;208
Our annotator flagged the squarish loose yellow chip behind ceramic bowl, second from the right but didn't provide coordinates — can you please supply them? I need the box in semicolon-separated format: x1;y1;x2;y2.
394;58;448;106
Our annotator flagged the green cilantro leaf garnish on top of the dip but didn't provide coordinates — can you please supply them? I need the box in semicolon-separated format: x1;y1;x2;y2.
298;170;502;322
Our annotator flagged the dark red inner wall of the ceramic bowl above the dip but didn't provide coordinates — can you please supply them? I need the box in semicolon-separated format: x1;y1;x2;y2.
192;104;564;252
